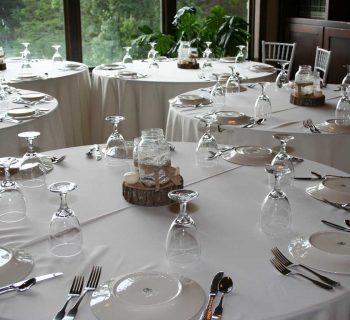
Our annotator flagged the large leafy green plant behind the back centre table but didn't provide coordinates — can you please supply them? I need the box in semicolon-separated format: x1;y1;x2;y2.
133;5;250;57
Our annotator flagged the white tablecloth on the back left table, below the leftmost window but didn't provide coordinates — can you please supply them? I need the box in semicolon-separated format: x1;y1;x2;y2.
2;60;91;147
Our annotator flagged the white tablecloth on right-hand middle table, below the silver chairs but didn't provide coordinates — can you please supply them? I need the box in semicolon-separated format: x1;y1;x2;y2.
166;84;350;172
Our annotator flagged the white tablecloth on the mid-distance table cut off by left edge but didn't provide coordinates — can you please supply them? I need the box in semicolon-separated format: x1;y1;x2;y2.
0;90;66;157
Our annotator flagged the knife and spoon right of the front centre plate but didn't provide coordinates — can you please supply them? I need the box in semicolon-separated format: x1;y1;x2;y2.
200;271;233;320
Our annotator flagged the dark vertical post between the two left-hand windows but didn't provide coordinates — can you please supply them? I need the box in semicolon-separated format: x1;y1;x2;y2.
63;0;83;62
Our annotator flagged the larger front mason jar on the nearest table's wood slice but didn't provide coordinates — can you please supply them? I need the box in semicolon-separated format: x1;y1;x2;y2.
137;128;171;187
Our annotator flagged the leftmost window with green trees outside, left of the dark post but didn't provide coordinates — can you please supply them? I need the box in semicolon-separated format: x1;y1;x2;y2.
0;0;65;59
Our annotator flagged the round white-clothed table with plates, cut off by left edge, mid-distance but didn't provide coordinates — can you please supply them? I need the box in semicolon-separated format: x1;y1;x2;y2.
0;87;66;157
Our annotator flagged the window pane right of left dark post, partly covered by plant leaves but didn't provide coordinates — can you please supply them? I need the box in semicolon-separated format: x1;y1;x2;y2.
80;0;160;65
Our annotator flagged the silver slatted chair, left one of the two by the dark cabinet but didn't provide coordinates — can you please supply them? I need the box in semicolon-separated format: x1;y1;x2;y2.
261;40;296;79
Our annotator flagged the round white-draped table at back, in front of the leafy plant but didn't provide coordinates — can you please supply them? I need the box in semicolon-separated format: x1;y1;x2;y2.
91;59;275;143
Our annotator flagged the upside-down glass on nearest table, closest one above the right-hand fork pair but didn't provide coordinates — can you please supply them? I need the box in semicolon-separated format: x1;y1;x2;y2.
260;165;292;237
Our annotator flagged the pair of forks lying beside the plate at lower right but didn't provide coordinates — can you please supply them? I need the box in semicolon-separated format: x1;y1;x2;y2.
270;247;341;290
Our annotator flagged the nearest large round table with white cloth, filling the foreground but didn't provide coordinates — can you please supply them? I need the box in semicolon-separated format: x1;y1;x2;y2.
0;143;350;320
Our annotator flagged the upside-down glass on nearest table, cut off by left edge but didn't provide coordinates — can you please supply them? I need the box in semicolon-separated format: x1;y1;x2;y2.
0;157;26;222
